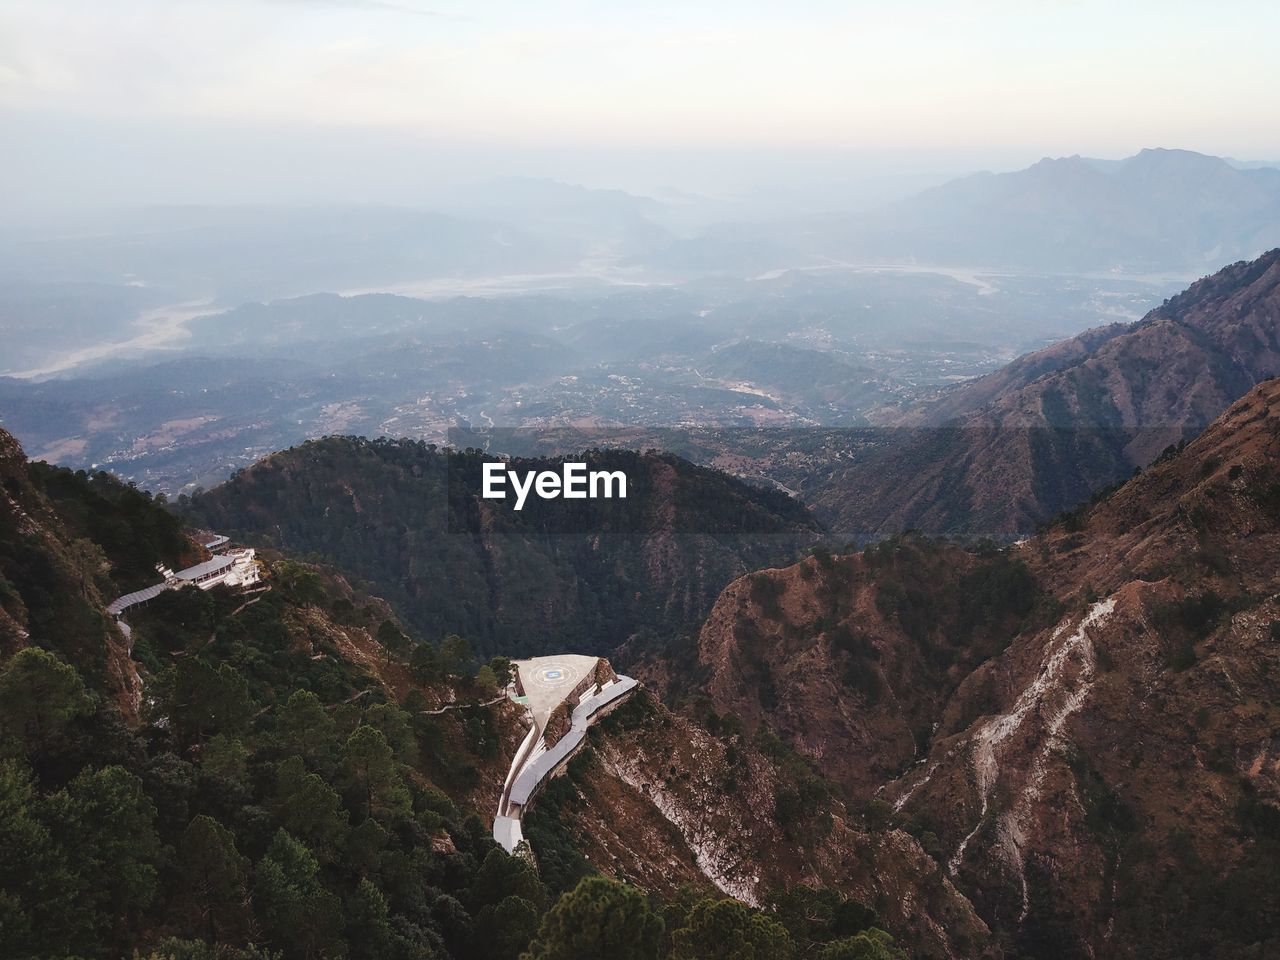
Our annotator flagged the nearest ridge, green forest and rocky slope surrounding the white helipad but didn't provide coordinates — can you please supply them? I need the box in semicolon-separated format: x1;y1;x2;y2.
0;431;988;960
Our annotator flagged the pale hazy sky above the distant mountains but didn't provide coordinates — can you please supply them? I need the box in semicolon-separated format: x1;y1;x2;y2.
0;0;1280;211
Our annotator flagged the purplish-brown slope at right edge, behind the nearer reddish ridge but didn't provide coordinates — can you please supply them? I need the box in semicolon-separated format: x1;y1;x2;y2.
814;250;1280;536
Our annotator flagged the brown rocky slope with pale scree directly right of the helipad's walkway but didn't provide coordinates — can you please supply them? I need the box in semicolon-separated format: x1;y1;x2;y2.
519;692;995;957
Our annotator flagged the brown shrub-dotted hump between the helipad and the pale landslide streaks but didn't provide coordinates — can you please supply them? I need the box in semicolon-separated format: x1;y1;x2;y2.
632;536;1047;803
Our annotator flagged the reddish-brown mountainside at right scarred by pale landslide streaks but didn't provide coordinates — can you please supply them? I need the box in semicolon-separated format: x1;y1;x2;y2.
653;380;1280;957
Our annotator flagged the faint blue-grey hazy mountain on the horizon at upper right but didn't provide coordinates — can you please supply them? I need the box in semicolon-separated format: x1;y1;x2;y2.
768;150;1280;274
